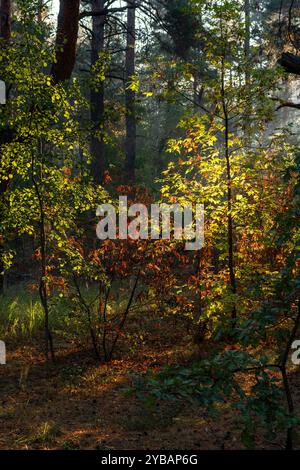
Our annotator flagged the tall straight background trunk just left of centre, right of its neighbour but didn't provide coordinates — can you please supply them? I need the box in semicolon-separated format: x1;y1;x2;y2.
124;1;136;182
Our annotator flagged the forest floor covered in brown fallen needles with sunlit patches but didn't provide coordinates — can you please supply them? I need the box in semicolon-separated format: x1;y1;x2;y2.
0;319;300;450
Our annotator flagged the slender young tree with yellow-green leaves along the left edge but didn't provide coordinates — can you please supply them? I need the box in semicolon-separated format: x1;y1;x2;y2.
0;2;108;360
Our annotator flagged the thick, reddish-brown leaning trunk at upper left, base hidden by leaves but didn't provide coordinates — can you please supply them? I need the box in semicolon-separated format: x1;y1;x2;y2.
51;0;80;83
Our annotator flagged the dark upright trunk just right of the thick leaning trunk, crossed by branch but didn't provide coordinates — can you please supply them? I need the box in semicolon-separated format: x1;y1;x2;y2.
90;0;106;184
